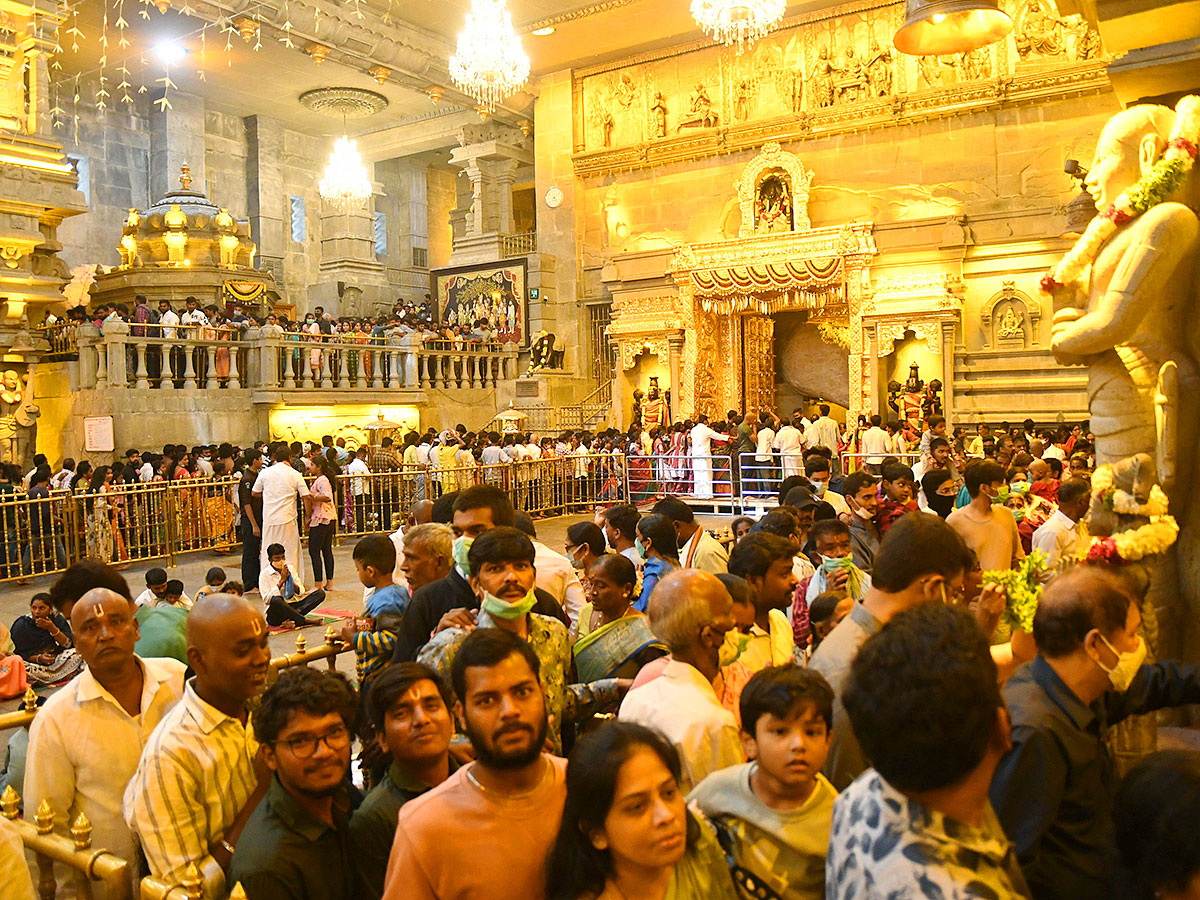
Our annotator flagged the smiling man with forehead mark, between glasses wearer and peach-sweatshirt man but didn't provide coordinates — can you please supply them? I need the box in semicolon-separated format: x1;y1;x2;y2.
350;662;458;900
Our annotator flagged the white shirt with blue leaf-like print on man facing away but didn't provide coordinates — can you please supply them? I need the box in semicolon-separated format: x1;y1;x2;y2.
826;769;1030;900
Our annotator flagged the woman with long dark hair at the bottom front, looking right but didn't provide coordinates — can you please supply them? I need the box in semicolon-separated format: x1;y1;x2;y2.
546;722;737;900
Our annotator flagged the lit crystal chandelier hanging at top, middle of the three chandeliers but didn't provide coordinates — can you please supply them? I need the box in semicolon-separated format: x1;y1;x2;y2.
450;0;529;113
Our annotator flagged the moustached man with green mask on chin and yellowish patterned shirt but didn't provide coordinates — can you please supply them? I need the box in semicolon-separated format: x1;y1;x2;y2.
416;526;629;752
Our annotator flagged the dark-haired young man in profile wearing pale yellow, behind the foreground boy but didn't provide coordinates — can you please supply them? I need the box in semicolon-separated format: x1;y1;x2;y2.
730;532;797;672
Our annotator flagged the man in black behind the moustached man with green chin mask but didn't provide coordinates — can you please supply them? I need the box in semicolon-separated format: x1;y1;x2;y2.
392;485;566;662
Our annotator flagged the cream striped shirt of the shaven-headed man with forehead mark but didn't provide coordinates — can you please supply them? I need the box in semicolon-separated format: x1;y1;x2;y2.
125;682;258;893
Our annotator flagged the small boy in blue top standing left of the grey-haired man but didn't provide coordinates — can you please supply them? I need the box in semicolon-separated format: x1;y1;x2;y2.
342;534;412;684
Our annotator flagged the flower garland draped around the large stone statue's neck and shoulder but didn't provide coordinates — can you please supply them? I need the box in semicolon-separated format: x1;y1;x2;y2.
1042;95;1200;294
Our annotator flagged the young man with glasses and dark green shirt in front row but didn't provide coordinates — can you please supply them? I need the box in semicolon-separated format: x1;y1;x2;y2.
229;666;361;900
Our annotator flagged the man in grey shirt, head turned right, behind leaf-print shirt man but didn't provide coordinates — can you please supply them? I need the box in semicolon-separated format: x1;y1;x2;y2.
809;515;972;791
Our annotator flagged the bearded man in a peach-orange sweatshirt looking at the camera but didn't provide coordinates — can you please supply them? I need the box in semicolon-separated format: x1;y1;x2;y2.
383;628;566;900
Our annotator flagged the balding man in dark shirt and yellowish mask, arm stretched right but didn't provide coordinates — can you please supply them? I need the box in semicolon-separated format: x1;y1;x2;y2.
991;566;1200;900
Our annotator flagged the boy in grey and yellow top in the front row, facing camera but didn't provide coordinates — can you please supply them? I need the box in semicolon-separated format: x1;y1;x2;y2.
688;665;838;900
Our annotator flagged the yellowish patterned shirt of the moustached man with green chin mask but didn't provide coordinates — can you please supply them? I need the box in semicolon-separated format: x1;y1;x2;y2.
416;612;619;754
